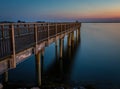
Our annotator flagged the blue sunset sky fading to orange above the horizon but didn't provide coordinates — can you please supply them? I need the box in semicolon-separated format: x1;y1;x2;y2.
0;0;120;21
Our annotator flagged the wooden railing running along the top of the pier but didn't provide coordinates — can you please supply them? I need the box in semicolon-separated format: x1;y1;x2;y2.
0;22;80;58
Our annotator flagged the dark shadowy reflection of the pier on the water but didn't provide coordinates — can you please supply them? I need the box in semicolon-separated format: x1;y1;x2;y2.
42;32;80;86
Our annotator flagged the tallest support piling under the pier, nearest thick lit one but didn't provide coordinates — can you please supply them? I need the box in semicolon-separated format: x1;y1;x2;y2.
35;52;41;86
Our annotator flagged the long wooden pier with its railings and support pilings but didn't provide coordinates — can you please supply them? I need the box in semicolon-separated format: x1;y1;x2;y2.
0;23;81;86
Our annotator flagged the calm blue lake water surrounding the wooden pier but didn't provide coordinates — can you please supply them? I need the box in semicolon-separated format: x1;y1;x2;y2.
0;23;120;89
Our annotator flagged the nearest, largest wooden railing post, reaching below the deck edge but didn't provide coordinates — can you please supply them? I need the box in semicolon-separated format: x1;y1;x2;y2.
10;24;16;68
